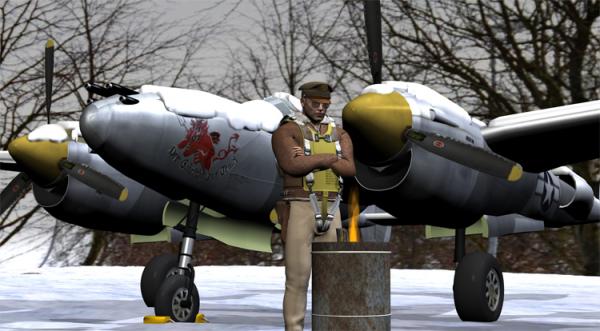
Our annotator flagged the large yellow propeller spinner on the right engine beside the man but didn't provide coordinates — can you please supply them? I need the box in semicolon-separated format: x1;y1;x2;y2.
342;92;412;165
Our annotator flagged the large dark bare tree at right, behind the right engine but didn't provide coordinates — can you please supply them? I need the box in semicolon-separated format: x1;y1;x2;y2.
322;0;600;275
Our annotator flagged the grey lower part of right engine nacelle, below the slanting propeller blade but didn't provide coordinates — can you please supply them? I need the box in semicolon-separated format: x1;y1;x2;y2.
356;146;600;227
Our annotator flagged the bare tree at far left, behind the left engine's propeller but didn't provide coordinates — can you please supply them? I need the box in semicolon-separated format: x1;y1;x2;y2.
0;0;226;264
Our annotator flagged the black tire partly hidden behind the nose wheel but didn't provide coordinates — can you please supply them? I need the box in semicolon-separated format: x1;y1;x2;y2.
140;254;179;307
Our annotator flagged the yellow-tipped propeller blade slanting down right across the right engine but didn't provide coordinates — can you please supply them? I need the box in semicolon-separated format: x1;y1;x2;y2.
406;129;523;182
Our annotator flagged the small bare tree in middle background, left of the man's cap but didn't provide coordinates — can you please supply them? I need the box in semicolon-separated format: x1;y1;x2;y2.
218;0;340;101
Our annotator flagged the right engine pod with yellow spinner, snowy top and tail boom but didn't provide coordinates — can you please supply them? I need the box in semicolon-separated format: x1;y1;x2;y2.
343;82;600;228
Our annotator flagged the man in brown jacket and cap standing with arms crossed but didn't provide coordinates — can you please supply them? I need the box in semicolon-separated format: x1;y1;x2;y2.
272;82;355;331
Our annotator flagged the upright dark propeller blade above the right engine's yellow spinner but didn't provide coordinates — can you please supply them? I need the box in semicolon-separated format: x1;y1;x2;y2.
364;0;383;84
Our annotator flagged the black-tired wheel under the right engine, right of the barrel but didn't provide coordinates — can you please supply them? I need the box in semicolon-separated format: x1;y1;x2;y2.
453;252;504;322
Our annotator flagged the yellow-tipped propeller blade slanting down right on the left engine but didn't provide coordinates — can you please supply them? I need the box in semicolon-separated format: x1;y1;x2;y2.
59;160;128;201
